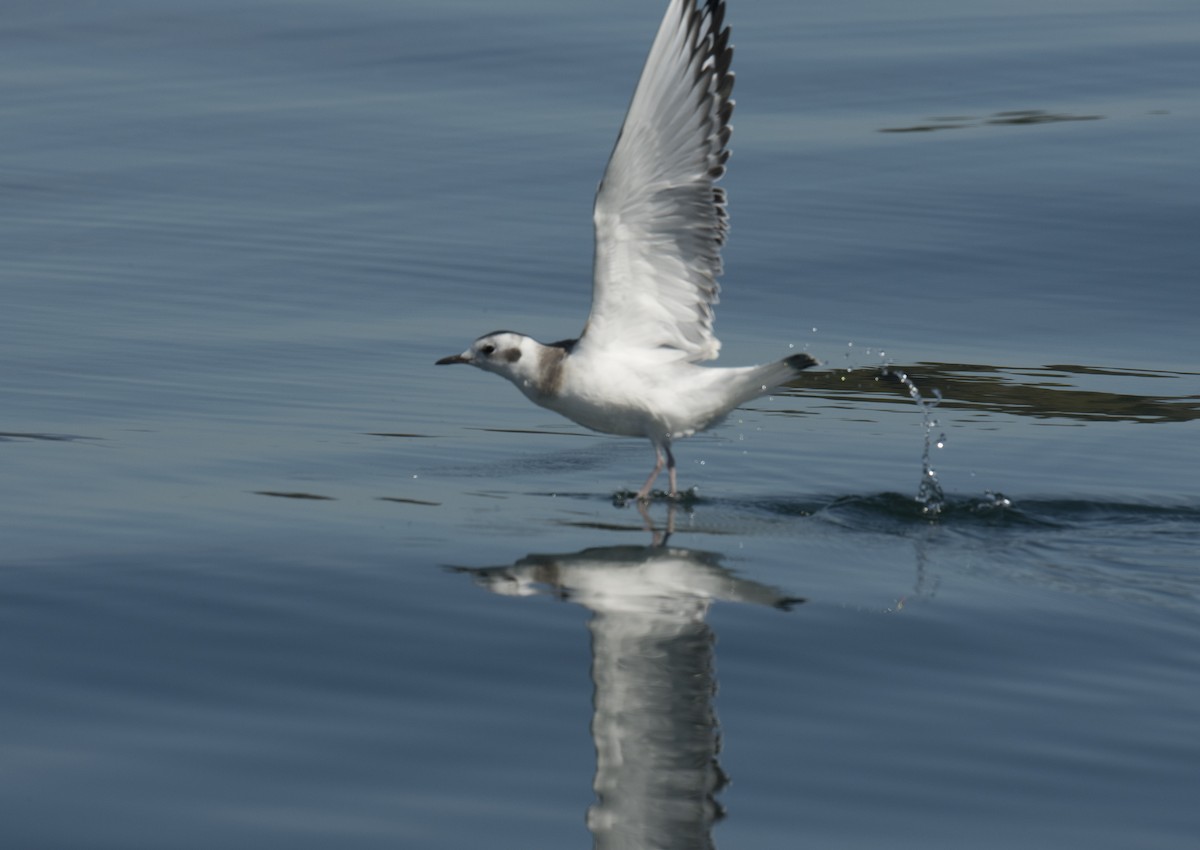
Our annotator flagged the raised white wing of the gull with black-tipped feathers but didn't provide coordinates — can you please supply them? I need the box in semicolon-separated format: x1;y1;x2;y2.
578;0;733;361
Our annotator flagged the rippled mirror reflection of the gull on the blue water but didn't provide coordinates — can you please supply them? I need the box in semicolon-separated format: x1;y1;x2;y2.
458;534;803;850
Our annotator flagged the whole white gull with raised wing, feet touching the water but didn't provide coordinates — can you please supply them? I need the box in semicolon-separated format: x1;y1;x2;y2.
437;0;817;502
